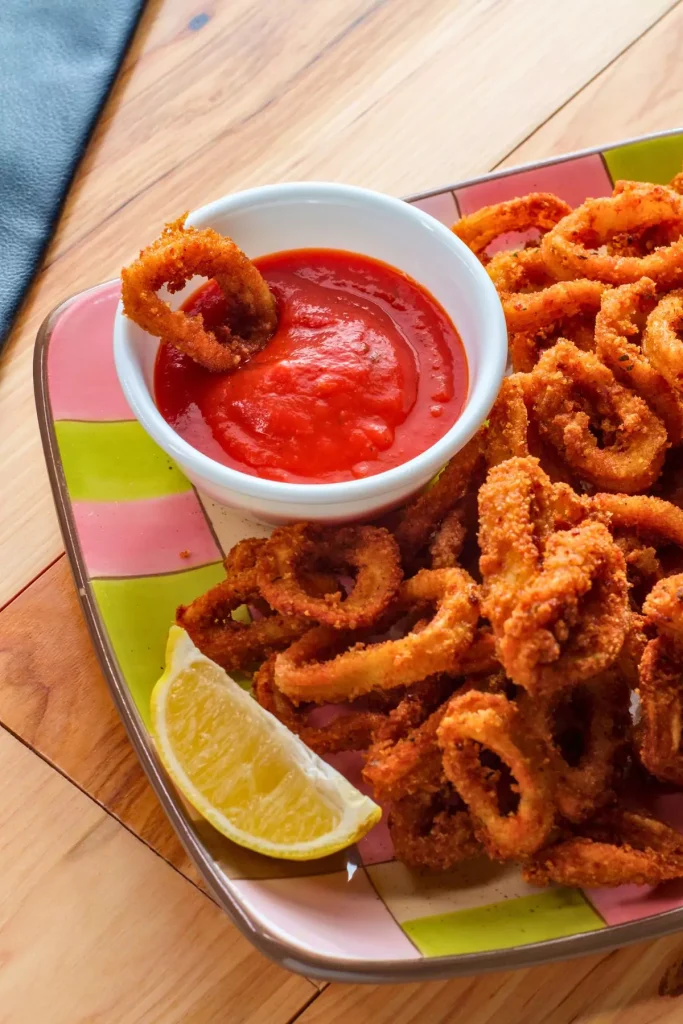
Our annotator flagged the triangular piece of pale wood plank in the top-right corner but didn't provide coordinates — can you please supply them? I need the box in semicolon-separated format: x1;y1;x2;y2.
500;4;683;167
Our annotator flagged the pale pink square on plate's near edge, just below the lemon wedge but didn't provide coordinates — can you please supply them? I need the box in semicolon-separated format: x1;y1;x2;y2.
230;865;420;966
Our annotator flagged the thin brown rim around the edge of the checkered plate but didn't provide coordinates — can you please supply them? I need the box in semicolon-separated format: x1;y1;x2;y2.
33;127;683;984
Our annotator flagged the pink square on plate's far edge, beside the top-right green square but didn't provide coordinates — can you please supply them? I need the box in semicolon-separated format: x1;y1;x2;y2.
456;154;612;216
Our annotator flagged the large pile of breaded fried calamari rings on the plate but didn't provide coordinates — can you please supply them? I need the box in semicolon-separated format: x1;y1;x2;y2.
178;176;683;886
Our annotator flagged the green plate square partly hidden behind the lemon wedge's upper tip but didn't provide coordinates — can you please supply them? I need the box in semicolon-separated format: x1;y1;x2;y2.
92;562;225;726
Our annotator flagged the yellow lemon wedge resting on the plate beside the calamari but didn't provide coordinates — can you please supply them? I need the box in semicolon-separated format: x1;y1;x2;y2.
152;626;382;860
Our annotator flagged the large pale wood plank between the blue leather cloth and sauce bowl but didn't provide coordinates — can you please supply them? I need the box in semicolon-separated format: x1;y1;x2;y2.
0;0;674;604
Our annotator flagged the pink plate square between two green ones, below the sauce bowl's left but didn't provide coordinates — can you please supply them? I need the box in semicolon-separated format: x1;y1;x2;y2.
73;490;222;577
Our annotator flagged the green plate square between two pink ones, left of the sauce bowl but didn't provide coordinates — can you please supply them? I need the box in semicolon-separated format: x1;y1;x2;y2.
54;420;191;502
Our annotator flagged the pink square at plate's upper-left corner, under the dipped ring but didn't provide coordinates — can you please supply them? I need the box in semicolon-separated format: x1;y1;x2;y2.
47;282;134;420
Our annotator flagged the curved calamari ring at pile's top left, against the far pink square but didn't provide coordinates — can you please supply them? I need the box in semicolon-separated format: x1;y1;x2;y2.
453;193;571;262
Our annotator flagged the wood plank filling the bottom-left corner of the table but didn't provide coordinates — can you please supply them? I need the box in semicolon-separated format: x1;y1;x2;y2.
0;730;316;1024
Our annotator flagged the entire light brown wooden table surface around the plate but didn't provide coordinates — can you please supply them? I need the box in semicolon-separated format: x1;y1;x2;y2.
0;0;683;1024
